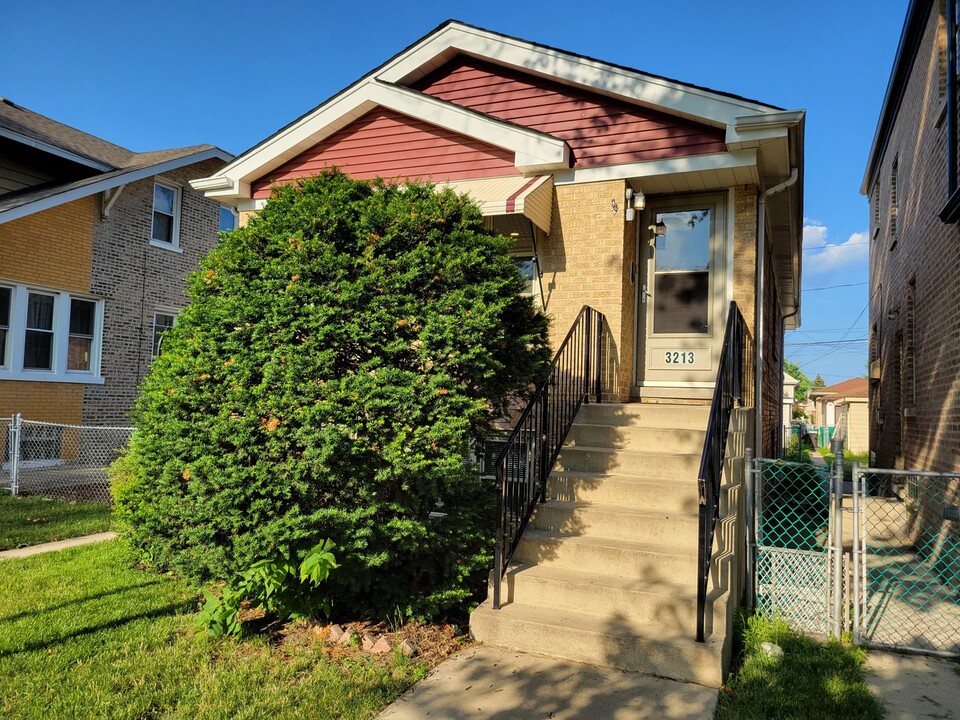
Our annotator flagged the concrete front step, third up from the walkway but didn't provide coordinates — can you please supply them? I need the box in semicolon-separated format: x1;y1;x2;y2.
513;527;697;583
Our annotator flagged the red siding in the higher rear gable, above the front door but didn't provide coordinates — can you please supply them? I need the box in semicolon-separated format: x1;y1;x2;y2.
414;56;727;167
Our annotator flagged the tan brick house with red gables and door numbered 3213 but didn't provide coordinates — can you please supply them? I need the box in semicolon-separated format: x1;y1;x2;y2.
193;21;804;462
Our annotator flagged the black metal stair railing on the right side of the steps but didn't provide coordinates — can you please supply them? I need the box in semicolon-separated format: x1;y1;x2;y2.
697;302;747;642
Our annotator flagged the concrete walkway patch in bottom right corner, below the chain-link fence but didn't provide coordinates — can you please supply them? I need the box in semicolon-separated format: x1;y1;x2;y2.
866;650;960;720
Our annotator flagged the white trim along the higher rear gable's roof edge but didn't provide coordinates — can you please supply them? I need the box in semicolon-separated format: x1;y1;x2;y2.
377;23;776;127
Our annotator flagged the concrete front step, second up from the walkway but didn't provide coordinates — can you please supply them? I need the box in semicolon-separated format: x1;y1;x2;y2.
501;563;697;633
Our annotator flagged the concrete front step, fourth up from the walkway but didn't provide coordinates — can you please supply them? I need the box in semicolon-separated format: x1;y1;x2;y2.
529;500;698;548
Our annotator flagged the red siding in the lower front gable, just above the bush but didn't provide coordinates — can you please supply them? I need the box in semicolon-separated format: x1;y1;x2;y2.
253;108;519;198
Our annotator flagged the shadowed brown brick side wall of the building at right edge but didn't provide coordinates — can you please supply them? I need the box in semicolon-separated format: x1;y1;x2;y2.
867;3;960;471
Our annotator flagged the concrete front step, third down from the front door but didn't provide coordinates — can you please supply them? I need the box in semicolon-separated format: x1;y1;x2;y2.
554;446;700;481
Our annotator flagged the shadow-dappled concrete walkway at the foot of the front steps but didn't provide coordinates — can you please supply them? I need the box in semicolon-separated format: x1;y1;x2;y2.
379;645;717;720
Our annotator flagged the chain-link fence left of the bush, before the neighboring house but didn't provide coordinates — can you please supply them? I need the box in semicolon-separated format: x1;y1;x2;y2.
0;415;133;504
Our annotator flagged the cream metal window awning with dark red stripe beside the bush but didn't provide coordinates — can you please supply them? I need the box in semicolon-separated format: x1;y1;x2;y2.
443;175;553;233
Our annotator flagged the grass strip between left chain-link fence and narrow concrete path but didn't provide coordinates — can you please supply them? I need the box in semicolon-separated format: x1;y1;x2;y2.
0;493;110;550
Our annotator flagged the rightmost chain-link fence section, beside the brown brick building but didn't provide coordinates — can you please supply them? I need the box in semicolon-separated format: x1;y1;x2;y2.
853;466;960;656
